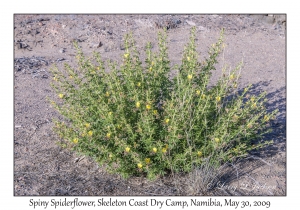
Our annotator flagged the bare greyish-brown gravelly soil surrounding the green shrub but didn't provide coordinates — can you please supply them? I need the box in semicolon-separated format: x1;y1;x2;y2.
14;14;286;196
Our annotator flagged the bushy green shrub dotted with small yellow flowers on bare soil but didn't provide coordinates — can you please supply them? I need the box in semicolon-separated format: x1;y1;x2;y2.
51;28;276;179
